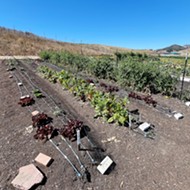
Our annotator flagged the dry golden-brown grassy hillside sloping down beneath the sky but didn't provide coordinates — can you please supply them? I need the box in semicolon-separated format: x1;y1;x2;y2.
0;27;151;56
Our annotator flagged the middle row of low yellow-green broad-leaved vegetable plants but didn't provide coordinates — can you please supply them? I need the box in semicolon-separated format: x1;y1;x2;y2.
38;66;129;126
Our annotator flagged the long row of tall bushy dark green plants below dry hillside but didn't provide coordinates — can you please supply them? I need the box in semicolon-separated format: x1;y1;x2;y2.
41;51;177;95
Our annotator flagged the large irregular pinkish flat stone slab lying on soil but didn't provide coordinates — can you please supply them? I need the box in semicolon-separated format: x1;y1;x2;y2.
11;164;44;190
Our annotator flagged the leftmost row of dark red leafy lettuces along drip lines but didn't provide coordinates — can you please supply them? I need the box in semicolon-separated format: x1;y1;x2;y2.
12;65;83;141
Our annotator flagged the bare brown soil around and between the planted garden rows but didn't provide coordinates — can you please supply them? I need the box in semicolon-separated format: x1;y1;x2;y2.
0;59;190;190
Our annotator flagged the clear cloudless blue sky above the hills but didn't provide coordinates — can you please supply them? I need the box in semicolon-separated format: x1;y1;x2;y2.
0;0;190;49
